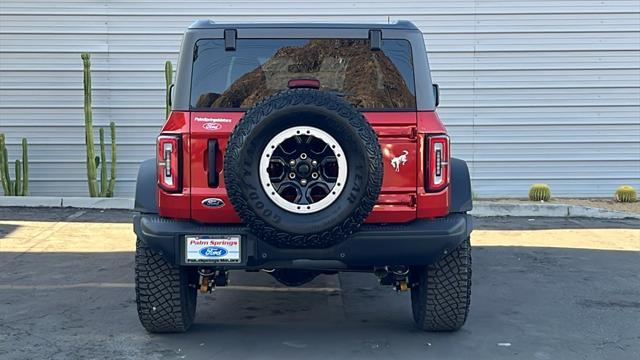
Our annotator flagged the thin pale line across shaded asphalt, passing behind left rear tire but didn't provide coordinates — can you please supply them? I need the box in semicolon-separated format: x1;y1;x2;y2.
0;283;340;293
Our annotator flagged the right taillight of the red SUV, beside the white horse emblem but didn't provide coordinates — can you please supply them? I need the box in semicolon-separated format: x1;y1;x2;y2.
425;135;449;191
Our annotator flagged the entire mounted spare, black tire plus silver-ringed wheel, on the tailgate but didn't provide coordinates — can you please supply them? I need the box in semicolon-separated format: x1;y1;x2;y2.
224;89;383;248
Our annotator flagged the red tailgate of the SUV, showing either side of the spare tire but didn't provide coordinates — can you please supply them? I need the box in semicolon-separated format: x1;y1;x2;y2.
189;111;419;223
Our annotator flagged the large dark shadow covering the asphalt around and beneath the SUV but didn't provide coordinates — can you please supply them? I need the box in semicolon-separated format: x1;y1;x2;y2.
0;246;640;359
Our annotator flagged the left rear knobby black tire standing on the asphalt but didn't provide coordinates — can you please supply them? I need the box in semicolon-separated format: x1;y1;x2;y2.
135;239;198;333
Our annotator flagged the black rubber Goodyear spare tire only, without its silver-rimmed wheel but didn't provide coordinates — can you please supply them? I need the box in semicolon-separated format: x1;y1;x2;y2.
224;89;383;248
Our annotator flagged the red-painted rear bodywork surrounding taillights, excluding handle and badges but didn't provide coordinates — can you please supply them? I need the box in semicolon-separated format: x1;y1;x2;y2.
158;112;449;223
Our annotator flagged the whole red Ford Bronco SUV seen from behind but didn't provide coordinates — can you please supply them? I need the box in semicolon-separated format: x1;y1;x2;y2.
134;21;472;332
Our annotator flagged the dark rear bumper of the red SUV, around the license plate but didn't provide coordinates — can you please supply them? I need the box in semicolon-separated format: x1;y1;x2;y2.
134;213;473;270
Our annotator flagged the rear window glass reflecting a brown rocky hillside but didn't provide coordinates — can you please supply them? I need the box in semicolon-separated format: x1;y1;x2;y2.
191;39;416;110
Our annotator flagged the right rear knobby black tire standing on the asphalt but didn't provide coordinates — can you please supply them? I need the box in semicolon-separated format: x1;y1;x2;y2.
410;238;471;331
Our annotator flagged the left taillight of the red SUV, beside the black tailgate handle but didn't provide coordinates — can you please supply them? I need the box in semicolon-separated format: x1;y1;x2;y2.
157;135;182;192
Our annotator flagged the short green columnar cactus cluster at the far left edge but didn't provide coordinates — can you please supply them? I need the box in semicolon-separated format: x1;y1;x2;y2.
0;134;29;196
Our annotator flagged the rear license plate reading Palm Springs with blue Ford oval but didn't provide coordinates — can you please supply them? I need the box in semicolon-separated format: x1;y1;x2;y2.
185;235;242;264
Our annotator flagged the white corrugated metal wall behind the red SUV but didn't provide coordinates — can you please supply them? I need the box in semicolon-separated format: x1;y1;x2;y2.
0;0;640;197
